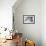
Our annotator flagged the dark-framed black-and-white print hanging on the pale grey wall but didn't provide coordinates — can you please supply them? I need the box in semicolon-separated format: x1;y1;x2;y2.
23;15;35;24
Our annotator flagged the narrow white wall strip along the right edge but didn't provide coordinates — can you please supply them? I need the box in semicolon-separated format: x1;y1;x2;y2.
41;0;46;46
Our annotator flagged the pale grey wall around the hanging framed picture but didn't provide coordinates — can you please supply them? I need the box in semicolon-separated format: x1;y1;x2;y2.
13;0;41;46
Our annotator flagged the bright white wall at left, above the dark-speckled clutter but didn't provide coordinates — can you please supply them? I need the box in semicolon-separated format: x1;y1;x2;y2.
0;0;16;29
